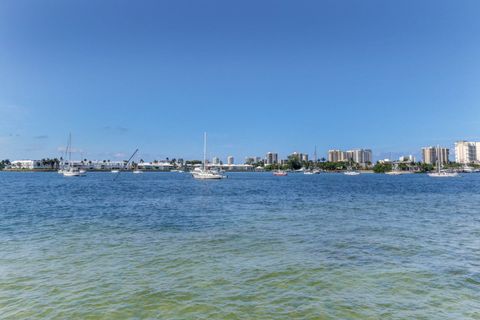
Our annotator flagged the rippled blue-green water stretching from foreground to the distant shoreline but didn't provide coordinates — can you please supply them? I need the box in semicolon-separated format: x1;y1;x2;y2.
0;172;480;319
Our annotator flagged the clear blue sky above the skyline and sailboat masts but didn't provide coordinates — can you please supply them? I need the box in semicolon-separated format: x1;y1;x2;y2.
0;0;480;160
